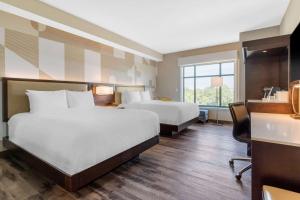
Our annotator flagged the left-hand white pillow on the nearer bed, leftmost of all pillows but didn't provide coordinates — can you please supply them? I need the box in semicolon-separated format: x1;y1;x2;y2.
26;90;68;114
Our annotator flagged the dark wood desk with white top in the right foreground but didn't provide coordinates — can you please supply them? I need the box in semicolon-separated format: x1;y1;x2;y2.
251;113;300;200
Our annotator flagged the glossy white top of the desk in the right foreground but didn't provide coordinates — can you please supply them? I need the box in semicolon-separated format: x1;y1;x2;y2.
251;113;300;147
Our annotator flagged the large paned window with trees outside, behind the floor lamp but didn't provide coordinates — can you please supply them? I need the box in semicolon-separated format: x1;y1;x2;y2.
182;62;234;107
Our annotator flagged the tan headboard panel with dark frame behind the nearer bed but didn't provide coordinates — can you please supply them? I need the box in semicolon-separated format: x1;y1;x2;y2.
2;78;90;122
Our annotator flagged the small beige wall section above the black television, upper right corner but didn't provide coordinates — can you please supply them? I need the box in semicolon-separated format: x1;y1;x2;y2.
280;0;300;35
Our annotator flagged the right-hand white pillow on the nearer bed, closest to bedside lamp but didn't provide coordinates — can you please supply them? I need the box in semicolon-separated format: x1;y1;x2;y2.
67;91;95;108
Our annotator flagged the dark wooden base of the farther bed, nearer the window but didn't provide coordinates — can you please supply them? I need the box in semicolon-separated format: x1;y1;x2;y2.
160;117;199;137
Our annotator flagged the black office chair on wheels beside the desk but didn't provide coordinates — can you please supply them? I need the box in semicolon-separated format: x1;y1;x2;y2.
229;103;252;180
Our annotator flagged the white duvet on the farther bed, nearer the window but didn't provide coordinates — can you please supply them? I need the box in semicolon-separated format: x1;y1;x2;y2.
120;100;199;125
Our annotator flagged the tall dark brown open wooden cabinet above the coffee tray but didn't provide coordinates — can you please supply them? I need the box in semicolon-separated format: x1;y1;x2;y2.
242;35;290;100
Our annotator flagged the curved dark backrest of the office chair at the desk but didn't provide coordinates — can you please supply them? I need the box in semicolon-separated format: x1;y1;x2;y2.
229;102;251;142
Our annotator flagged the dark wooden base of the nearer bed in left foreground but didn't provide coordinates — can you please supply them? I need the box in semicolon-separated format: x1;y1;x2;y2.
4;136;159;192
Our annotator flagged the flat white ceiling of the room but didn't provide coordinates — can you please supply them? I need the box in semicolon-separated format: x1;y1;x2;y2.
38;0;289;54
